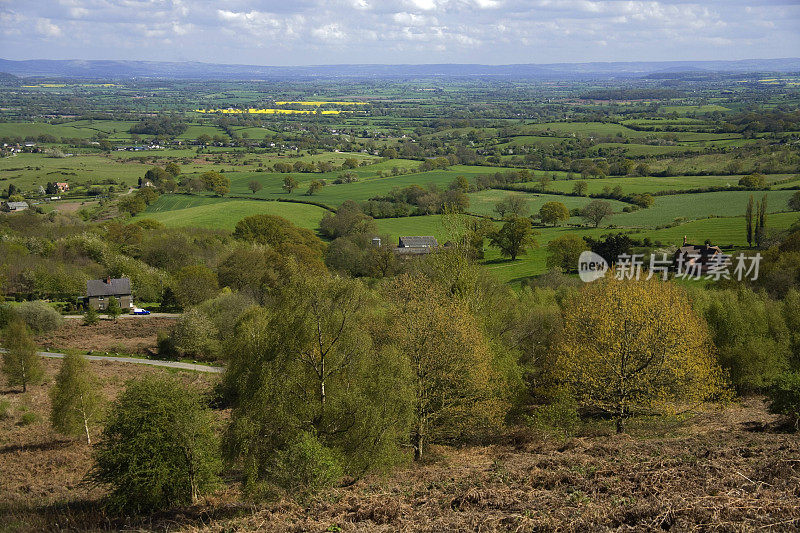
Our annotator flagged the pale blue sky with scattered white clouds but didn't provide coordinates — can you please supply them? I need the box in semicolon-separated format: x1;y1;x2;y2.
0;0;800;65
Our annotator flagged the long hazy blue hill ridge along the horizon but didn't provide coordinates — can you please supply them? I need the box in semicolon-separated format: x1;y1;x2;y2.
0;58;800;79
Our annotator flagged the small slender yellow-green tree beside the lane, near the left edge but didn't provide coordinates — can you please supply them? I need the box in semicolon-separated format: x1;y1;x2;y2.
50;354;102;445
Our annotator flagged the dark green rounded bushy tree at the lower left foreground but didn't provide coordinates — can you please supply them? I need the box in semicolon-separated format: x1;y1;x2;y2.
88;377;221;514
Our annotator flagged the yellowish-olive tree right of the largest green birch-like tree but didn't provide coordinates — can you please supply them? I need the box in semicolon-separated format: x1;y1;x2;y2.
386;276;509;460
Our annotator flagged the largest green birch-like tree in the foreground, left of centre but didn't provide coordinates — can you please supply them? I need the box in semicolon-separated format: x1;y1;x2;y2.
225;275;410;491
